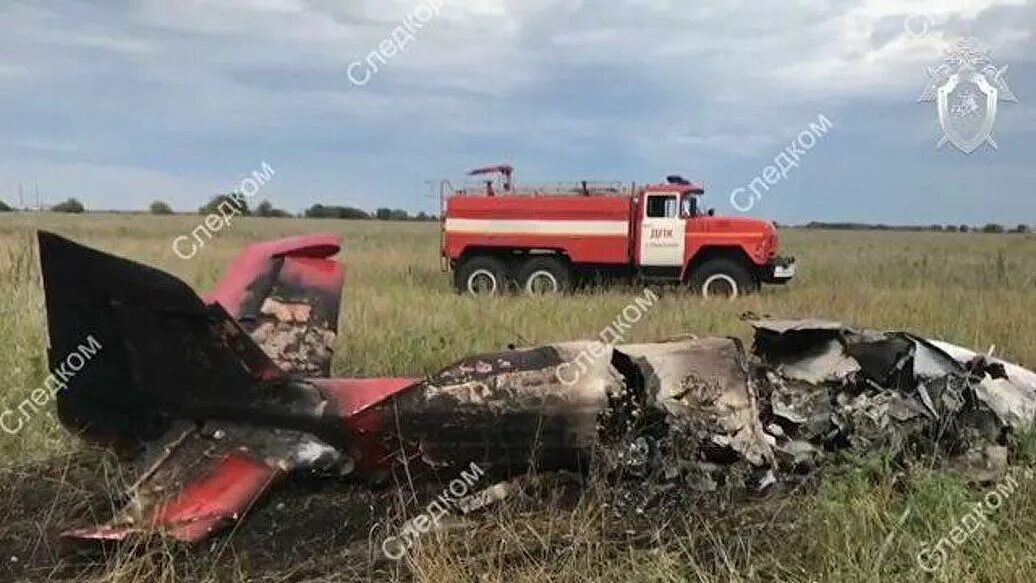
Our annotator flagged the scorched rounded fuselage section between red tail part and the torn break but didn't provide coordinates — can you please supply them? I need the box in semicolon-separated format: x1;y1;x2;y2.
368;343;622;476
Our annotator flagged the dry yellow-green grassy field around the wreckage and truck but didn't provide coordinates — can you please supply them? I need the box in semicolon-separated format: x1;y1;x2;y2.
0;214;1036;583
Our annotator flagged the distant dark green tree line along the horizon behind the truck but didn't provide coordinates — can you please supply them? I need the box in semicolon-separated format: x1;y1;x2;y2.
0;194;1033;234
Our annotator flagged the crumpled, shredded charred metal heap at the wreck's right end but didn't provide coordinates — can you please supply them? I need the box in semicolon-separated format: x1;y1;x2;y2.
752;321;1036;470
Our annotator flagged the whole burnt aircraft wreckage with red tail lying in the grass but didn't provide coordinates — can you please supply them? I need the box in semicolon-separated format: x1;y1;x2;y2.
39;232;1036;542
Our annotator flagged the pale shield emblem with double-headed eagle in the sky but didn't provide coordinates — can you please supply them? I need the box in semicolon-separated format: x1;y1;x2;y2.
918;38;1018;154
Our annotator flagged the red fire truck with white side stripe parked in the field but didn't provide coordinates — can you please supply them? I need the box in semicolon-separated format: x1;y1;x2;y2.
441;166;796;297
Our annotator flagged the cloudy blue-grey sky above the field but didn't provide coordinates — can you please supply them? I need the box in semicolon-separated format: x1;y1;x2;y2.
0;0;1036;225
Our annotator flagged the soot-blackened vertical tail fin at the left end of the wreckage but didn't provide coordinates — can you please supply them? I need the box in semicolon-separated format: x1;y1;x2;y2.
39;232;320;441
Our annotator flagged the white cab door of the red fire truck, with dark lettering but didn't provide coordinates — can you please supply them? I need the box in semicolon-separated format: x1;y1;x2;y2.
640;193;686;268
